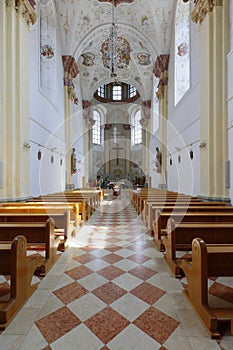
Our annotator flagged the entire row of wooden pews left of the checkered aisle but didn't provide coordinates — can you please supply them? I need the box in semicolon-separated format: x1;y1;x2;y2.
0;189;103;330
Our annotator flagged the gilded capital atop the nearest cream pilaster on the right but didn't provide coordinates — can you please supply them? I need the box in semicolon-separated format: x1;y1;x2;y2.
191;0;223;24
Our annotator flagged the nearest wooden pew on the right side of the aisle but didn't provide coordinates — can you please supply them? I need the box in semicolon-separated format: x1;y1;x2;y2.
181;238;233;339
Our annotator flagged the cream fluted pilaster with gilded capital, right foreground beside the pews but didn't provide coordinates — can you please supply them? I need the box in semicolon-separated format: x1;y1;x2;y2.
192;0;228;201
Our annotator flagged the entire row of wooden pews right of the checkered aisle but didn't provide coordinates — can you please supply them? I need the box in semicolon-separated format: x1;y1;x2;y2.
131;188;233;339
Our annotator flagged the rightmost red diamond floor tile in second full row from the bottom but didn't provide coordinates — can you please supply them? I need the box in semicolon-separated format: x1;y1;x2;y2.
130;282;165;305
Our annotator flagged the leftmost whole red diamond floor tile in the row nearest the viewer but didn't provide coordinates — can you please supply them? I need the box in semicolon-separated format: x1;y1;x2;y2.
36;307;81;344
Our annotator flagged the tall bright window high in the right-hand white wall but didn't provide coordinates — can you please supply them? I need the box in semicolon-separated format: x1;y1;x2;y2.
174;0;190;105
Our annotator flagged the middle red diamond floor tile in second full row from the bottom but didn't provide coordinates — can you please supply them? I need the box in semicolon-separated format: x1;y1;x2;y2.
92;282;127;305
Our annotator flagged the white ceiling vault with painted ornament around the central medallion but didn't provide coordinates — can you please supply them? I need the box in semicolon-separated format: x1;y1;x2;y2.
52;0;176;101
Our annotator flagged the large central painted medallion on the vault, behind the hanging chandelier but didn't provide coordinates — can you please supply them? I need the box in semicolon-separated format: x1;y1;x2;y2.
101;36;131;69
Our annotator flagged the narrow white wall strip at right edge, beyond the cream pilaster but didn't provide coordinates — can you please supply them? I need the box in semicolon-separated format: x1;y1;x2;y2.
227;0;233;204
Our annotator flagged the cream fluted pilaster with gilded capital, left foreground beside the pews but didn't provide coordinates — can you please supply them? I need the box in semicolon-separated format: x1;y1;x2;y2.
0;0;37;200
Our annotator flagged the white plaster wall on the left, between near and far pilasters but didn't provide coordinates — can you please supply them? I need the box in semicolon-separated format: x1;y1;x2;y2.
30;10;65;196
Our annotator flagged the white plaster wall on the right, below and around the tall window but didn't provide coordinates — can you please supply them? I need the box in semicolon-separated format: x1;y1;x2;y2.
167;10;200;195
